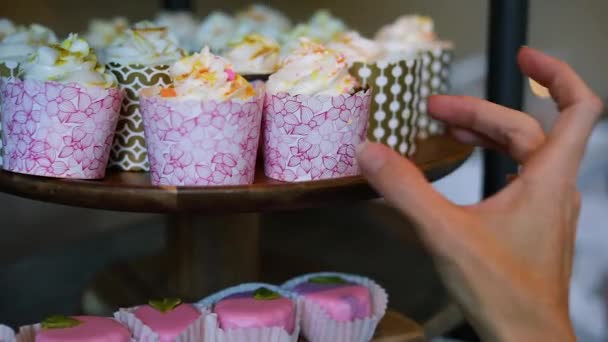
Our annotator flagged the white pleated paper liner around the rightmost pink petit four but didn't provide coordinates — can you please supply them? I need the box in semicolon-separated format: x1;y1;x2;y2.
281;272;388;342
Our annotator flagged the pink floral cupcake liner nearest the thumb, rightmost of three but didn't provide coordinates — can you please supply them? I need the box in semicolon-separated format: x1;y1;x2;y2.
263;91;371;182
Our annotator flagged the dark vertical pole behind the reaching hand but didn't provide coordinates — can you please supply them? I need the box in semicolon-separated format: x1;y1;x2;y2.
483;0;528;197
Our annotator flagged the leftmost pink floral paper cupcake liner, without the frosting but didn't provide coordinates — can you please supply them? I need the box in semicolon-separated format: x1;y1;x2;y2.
0;79;122;179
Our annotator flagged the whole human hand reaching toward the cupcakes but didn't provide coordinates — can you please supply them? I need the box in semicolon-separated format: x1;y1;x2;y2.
358;48;603;341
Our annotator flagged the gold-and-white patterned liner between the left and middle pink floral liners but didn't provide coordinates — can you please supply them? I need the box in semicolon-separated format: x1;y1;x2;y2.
106;62;172;171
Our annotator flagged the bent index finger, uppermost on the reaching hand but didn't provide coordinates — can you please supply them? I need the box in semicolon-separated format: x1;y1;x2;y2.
519;48;603;177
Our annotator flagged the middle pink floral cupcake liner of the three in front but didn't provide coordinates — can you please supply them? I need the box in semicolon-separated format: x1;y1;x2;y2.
140;87;264;186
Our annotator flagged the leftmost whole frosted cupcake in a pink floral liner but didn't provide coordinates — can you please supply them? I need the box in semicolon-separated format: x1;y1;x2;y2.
1;34;122;179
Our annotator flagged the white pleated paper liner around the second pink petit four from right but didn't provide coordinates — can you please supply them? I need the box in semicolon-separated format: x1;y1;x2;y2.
196;283;302;342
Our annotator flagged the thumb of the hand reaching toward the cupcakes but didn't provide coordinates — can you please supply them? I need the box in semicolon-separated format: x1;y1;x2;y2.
357;142;453;227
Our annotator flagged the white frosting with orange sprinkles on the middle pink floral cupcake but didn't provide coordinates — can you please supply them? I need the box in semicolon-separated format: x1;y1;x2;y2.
161;48;256;100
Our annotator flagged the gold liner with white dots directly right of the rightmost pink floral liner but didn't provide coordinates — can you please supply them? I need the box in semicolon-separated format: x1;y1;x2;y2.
350;59;421;157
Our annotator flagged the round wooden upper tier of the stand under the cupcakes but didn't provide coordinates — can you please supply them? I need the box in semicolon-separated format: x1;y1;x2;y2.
0;137;472;214
